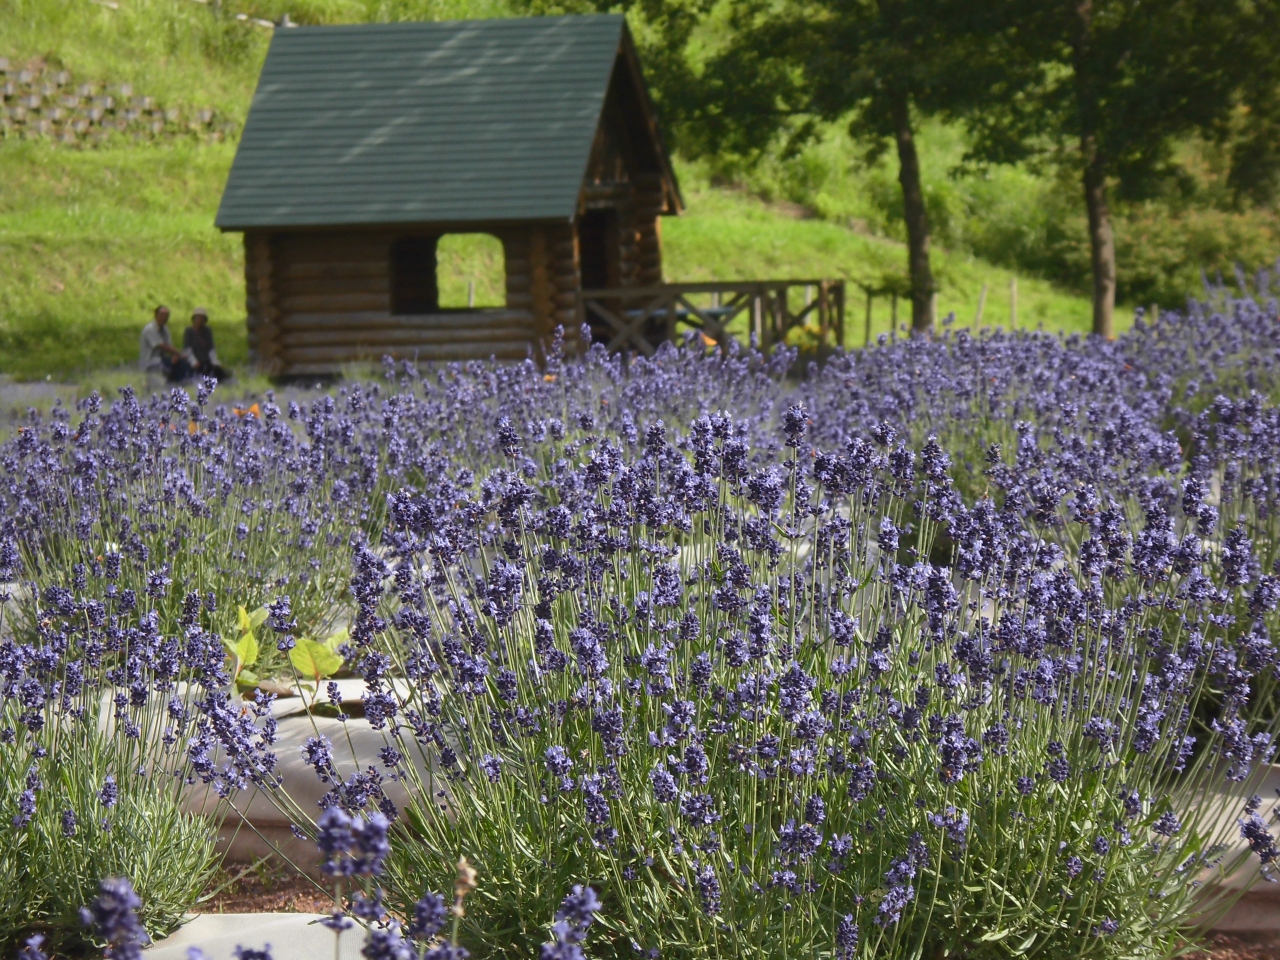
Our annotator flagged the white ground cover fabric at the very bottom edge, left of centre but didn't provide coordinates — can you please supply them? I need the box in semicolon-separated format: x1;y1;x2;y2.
143;914;365;960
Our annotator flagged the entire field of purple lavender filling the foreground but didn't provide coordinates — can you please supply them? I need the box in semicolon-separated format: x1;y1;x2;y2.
0;295;1280;960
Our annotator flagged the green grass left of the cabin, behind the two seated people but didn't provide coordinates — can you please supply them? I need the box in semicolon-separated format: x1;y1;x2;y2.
0;143;246;378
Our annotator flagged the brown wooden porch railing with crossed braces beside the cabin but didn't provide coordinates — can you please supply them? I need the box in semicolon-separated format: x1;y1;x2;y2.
579;280;845;356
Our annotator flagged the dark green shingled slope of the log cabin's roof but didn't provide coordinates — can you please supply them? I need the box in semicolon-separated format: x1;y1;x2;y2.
216;15;640;230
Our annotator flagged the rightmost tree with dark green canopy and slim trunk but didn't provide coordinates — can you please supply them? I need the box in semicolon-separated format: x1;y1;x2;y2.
968;0;1280;338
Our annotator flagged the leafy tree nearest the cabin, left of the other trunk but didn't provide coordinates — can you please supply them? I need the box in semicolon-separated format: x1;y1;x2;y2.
685;0;1012;335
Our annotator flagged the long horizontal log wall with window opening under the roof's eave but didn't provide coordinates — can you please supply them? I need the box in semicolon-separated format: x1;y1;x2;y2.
246;228;542;376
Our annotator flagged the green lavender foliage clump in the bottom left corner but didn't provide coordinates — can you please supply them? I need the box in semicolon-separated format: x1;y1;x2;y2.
0;600;221;955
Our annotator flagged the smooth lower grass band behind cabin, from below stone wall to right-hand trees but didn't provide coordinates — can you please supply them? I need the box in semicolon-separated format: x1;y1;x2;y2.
0;142;1088;378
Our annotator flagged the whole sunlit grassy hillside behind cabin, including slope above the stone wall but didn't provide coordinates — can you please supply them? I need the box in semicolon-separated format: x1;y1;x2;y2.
0;0;1167;378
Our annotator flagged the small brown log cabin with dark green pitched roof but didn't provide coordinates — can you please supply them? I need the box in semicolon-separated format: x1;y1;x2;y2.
216;14;684;376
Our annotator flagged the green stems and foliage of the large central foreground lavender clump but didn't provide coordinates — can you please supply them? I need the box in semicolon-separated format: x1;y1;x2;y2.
332;419;1271;957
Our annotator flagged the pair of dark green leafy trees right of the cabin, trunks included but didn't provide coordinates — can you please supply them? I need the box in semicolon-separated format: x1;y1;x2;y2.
573;0;1280;335
